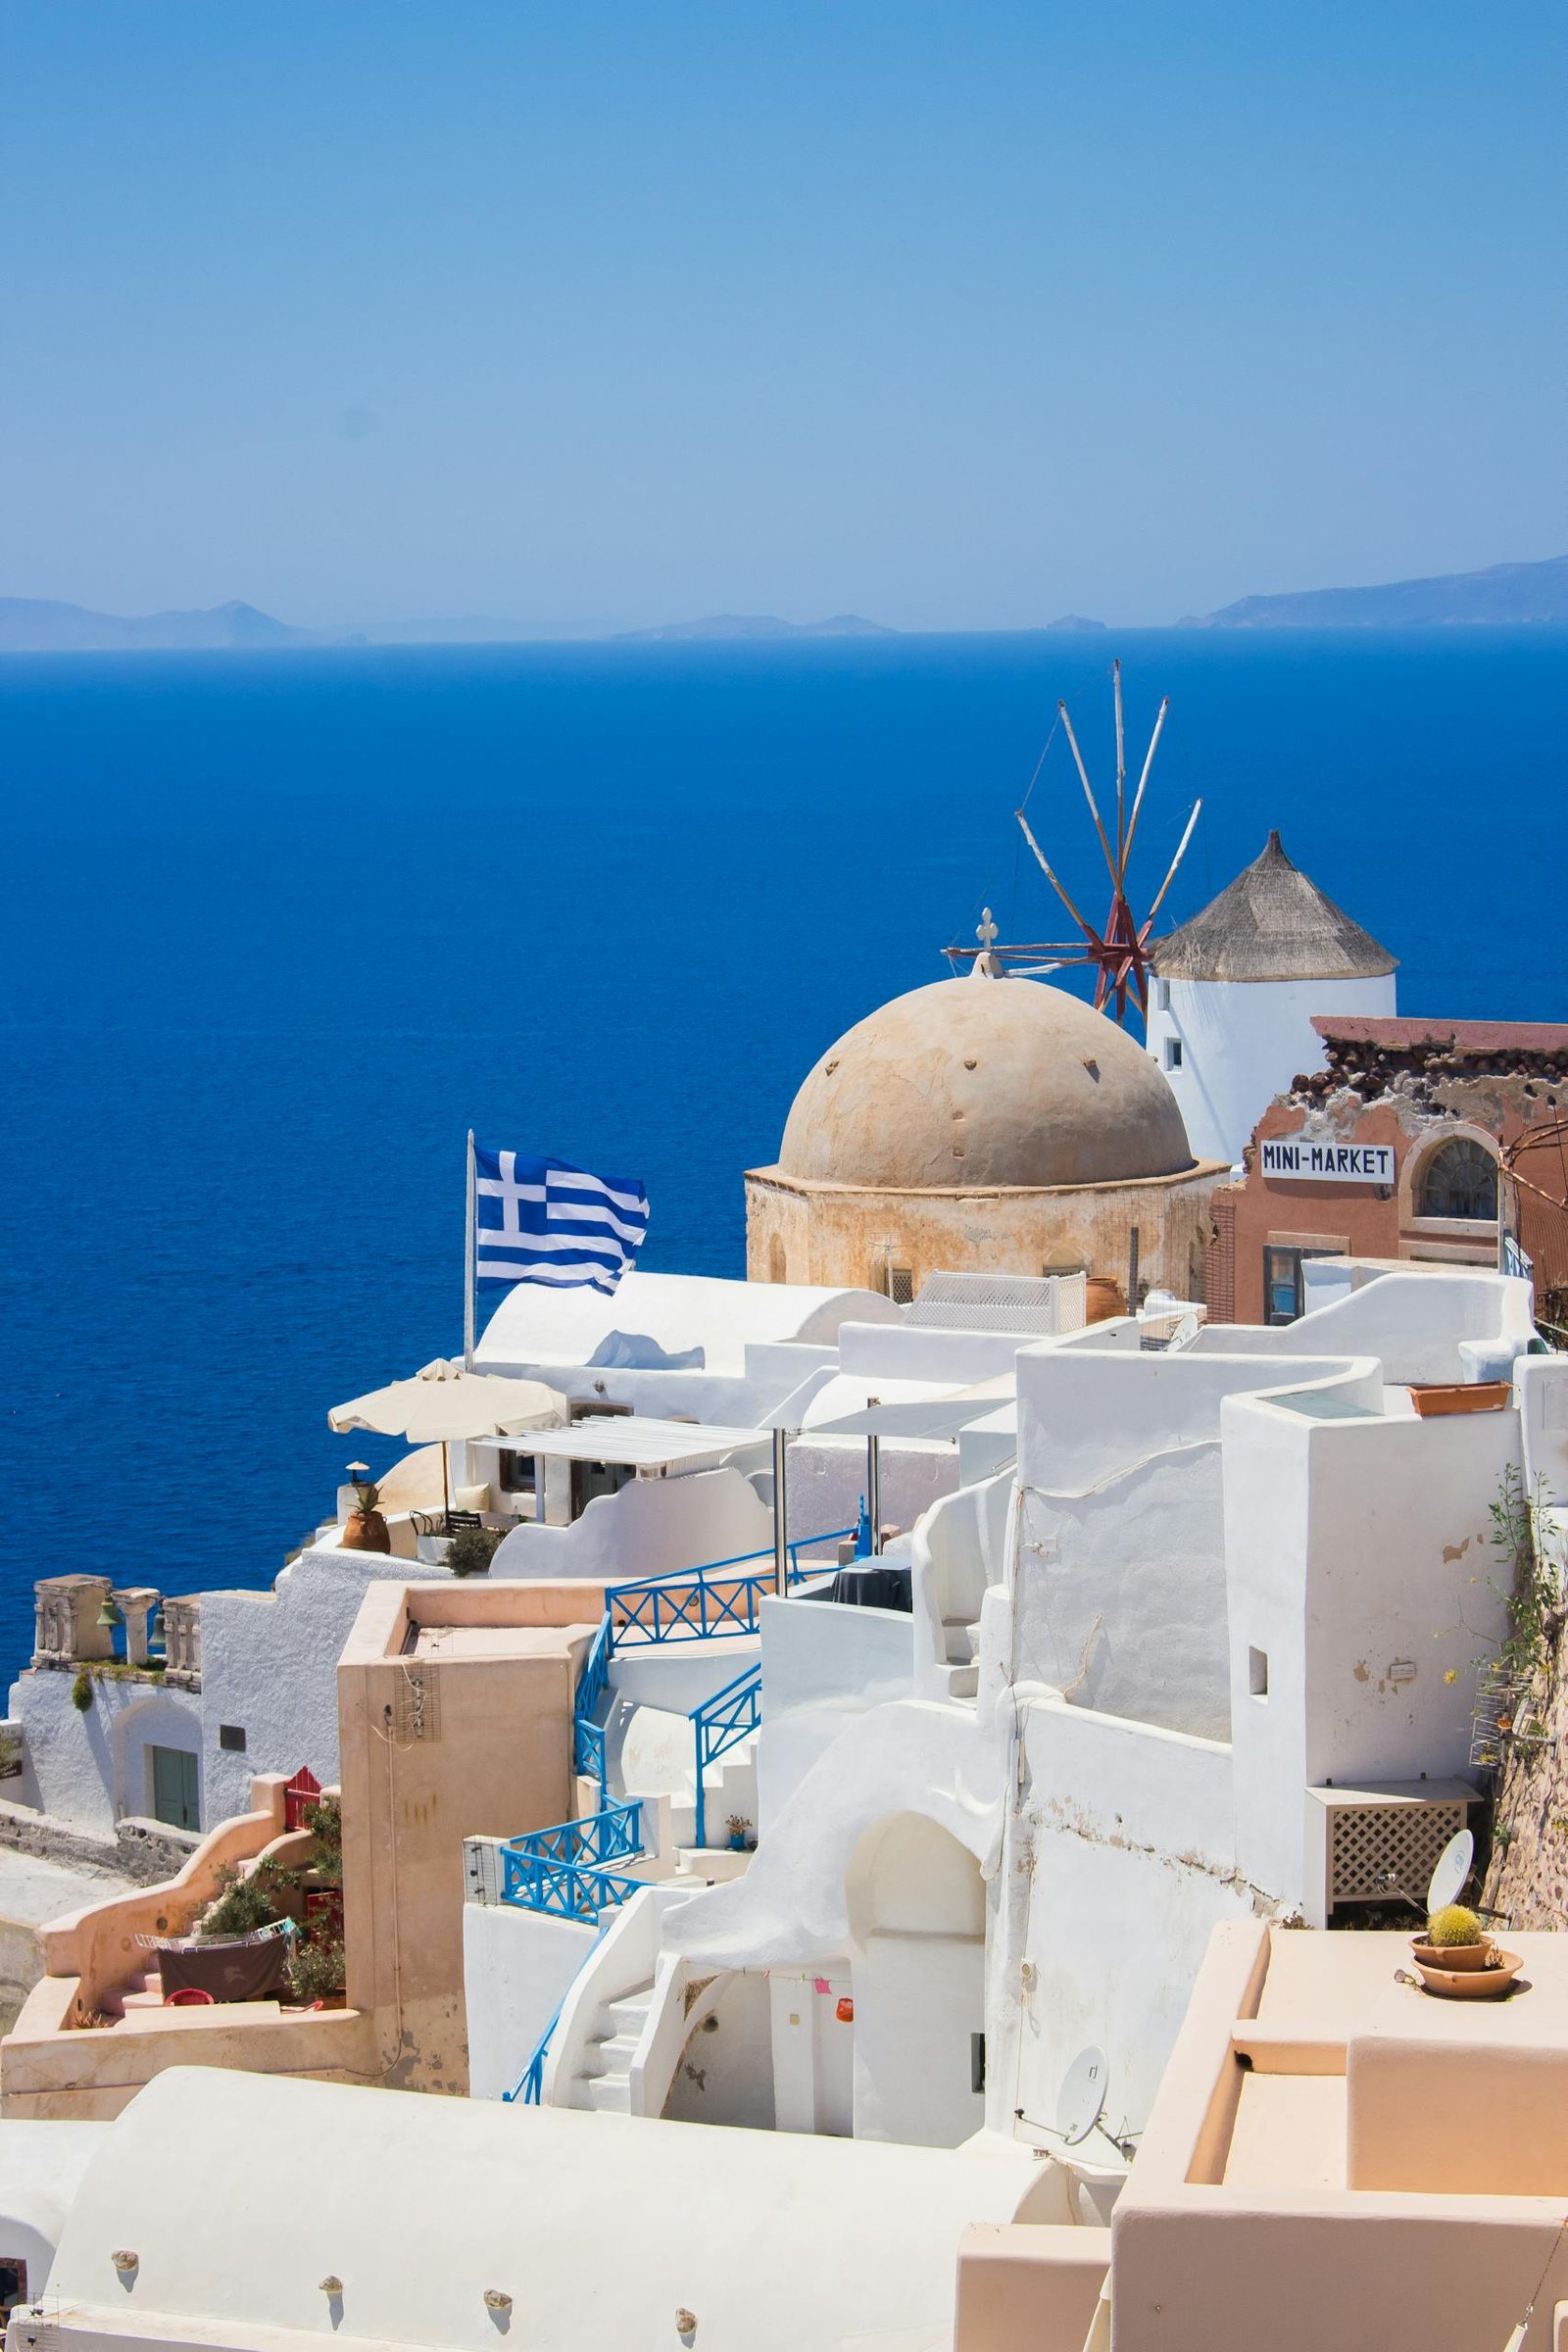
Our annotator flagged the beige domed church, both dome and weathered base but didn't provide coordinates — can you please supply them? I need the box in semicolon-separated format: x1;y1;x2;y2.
745;957;1227;1298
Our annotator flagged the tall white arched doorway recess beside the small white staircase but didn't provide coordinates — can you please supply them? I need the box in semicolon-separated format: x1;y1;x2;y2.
847;1813;985;2147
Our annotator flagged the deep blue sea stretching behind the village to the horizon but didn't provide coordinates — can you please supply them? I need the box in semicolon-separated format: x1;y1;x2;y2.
0;630;1568;1680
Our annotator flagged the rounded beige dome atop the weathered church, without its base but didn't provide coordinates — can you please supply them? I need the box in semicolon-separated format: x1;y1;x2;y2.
778;969;1195;1193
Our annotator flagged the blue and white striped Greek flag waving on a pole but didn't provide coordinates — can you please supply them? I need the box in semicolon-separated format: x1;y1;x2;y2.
472;1143;649;1292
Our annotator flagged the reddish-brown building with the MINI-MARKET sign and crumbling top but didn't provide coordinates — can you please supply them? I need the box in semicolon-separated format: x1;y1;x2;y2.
1206;1016;1568;1324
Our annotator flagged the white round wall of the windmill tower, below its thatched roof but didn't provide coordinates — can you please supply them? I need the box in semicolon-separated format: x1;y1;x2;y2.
1150;971;1394;1166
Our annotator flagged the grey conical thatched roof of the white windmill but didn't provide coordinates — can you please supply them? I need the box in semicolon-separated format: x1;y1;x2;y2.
1150;833;1394;981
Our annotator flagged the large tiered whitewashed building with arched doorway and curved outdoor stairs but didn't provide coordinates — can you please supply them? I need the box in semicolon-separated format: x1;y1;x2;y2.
466;1272;1542;2164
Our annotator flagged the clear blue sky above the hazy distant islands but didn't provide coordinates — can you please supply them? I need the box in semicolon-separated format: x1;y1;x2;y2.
0;0;1568;628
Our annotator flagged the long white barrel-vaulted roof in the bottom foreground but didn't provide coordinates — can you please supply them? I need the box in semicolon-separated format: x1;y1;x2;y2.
39;2070;1044;2352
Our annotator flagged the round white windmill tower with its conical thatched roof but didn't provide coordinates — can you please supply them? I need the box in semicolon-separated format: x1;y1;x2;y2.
1148;833;1396;1166
